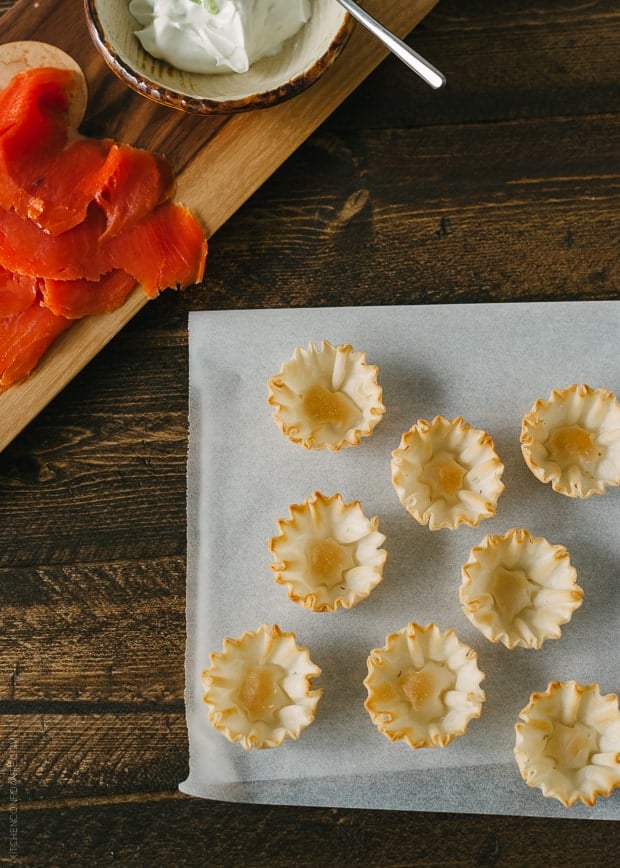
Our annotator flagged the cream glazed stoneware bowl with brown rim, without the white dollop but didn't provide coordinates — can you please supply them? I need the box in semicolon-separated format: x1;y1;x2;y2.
84;0;354;114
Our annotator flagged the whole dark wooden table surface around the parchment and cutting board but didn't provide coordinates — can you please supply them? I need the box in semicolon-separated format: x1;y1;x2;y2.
0;0;620;868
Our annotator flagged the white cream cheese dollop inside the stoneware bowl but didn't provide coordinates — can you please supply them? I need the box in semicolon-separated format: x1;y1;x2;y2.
129;0;312;74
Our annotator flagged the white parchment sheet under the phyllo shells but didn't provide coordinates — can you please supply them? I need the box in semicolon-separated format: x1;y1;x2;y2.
180;301;620;820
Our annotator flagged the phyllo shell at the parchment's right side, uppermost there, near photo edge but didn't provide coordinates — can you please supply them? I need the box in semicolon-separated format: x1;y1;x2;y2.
521;385;620;498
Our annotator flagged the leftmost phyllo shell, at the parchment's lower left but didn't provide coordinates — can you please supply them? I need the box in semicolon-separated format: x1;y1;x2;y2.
202;624;322;750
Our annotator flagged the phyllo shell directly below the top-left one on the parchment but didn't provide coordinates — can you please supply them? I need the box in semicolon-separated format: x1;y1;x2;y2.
269;491;387;612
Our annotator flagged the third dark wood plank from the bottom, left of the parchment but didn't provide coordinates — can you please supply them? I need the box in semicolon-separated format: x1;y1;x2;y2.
0;557;185;700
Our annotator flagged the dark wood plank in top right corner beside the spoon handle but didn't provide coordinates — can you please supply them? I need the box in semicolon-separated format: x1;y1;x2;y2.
327;0;620;128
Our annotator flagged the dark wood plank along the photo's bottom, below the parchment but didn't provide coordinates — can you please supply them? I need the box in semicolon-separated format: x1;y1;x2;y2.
0;797;618;868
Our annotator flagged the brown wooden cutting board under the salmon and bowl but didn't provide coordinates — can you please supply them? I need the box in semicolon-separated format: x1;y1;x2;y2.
0;0;437;450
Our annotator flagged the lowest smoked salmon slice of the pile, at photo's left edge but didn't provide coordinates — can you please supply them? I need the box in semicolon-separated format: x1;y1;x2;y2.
0;300;72;392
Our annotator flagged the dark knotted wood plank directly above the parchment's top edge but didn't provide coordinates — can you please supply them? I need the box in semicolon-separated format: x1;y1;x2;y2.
185;115;620;307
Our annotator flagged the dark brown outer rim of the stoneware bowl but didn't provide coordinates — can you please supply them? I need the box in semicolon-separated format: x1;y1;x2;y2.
83;0;355;115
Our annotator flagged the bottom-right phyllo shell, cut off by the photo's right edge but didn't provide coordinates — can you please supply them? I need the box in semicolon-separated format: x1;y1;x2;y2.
514;681;620;808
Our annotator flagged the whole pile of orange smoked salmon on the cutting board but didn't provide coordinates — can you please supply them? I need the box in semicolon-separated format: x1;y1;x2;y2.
0;68;208;391
